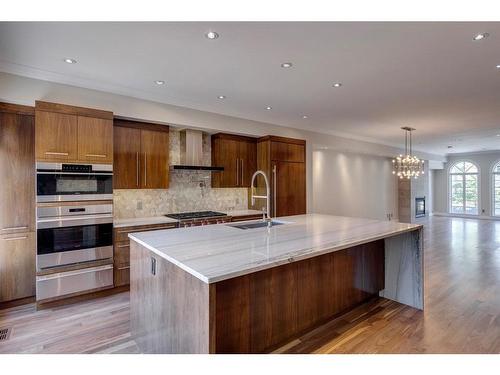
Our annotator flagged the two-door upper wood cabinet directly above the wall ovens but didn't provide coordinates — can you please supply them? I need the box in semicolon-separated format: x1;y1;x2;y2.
35;101;113;164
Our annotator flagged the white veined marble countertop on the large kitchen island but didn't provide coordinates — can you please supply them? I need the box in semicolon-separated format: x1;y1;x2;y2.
129;214;421;283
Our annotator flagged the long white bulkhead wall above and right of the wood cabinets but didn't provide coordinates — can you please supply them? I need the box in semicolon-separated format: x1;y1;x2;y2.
0;72;446;217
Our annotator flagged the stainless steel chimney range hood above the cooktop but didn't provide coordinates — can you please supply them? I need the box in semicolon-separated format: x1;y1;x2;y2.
173;129;224;171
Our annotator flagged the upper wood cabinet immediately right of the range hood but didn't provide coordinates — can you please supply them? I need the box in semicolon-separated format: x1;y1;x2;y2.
212;133;257;188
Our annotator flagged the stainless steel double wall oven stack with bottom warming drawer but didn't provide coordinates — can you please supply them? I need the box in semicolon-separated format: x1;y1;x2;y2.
36;163;113;301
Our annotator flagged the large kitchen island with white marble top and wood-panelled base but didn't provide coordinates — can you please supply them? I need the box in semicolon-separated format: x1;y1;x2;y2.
129;214;424;353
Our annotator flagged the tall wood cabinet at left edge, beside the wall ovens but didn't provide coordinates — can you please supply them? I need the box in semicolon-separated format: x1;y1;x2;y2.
0;103;36;302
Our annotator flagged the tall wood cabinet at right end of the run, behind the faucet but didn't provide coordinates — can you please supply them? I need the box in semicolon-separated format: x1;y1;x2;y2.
256;136;306;217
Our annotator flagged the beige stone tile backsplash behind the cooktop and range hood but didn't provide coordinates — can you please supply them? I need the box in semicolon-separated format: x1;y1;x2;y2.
113;129;248;219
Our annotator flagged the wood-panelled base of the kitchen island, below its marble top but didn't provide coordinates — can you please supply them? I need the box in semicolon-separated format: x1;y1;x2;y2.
130;229;423;353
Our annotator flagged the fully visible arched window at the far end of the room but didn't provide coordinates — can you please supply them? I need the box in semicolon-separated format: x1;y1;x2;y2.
449;161;479;215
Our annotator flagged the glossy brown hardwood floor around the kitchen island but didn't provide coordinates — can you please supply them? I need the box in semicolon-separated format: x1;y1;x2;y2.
0;217;500;353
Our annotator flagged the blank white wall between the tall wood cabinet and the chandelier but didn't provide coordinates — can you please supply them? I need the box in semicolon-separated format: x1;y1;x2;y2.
312;150;397;220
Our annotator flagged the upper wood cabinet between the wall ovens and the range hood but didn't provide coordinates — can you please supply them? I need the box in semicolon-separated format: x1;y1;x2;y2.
113;119;169;189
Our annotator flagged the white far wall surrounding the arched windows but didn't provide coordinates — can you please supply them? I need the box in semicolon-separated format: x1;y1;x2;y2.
434;151;500;216
